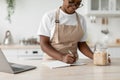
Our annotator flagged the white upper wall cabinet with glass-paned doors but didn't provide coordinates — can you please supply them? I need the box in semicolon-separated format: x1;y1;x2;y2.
88;0;120;16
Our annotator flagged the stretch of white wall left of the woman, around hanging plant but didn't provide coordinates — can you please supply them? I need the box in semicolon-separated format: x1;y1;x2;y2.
0;0;62;43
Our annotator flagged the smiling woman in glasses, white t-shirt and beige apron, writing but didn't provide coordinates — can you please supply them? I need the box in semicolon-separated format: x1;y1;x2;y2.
38;0;93;63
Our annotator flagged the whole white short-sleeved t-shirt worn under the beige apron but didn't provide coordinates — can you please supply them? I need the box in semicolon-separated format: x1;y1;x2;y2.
37;9;87;42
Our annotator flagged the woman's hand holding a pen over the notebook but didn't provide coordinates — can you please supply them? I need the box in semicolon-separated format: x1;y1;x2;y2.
62;54;76;64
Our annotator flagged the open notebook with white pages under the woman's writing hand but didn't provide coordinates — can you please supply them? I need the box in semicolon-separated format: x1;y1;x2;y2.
43;60;86;69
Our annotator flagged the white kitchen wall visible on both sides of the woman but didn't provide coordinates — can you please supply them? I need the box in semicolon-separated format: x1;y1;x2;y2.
0;0;120;43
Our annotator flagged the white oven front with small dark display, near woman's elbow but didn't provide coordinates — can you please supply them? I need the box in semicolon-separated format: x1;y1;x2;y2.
18;49;43;59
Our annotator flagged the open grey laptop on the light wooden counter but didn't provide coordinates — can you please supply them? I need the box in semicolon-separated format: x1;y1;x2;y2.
0;49;36;74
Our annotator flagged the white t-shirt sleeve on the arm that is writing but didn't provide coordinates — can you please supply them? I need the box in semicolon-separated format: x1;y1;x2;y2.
37;14;50;37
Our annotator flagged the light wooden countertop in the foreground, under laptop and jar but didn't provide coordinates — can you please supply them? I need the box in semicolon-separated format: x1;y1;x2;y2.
0;58;120;80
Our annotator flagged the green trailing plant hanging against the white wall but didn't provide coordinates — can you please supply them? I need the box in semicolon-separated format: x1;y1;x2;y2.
6;0;15;23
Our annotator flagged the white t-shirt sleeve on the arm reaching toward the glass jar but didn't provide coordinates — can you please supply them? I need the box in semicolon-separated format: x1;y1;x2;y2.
80;16;87;42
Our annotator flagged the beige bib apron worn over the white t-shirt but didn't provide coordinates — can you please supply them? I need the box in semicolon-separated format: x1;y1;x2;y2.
45;9;83;59
